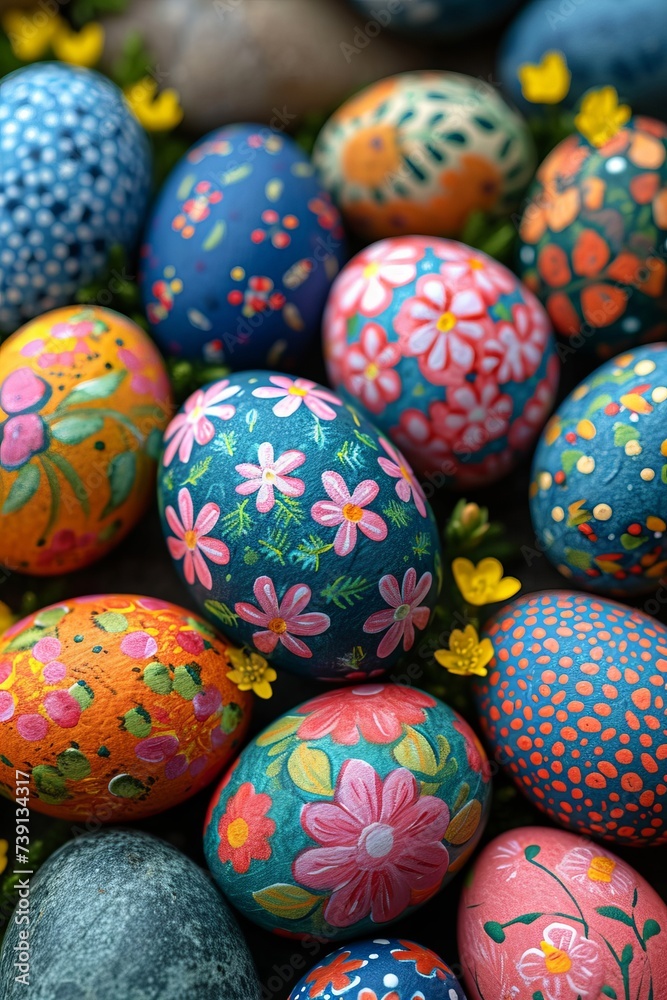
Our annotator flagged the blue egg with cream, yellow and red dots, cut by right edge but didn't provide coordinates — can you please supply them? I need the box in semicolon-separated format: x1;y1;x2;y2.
530;344;667;592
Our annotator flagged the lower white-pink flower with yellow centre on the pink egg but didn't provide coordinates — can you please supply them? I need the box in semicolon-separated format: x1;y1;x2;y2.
517;922;605;1000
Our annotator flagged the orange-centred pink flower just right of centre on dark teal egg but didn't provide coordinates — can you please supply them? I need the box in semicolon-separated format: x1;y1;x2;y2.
310;471;387;556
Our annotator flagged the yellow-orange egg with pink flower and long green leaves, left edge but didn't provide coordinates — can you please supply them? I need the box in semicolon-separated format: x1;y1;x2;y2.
0;306;171;575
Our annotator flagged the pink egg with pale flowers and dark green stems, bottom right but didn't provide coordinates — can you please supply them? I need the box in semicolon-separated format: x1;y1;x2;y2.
458;826;667;1000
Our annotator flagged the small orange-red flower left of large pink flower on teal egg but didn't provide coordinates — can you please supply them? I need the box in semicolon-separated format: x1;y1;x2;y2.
218;781;276;874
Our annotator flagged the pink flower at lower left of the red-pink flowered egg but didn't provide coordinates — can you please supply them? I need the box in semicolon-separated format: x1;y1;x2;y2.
345;323;401;413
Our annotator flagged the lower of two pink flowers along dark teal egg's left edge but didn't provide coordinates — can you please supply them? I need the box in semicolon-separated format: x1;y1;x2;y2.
164;486;229;590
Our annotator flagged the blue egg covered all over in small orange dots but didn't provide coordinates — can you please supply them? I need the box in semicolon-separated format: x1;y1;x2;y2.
476;590;667;847
